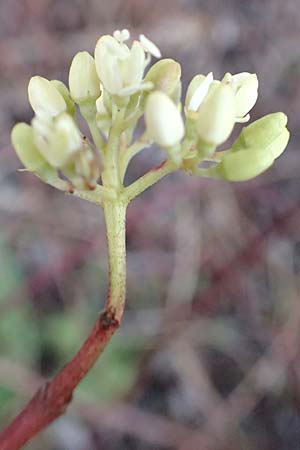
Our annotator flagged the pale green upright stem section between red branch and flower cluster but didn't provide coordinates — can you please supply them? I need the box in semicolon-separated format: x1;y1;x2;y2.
104;200;127;320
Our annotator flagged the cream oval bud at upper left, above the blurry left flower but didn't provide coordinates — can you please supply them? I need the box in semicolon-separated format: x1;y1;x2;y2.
28;76;67;117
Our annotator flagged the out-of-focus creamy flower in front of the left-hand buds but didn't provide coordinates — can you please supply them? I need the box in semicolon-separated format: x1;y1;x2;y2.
32;112;82;168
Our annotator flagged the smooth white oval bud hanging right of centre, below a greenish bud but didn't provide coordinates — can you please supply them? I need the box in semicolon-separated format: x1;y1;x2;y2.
145;91;184;147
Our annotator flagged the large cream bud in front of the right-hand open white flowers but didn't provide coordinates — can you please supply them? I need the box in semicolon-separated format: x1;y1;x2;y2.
196;83;235;146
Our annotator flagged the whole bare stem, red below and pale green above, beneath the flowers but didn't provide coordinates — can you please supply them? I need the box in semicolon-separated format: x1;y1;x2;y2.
0;201;126;450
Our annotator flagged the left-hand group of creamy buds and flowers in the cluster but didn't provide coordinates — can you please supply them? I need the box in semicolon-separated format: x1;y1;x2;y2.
12;76;100;192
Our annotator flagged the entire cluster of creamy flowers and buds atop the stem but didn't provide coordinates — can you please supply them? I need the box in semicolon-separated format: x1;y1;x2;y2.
12;30;289;201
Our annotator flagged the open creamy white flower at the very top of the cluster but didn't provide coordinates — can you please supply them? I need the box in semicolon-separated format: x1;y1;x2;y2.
95;30;161;96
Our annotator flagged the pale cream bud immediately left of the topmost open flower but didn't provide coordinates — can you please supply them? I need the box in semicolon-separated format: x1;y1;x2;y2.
69;52;100;103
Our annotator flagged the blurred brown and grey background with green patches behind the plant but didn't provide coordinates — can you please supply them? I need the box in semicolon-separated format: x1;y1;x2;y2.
0;0;300;450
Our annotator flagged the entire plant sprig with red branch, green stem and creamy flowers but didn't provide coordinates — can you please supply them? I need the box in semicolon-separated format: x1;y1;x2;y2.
0;30;289;450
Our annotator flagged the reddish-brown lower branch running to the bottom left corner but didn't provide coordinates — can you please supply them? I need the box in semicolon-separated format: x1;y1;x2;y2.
0;306;120;450
